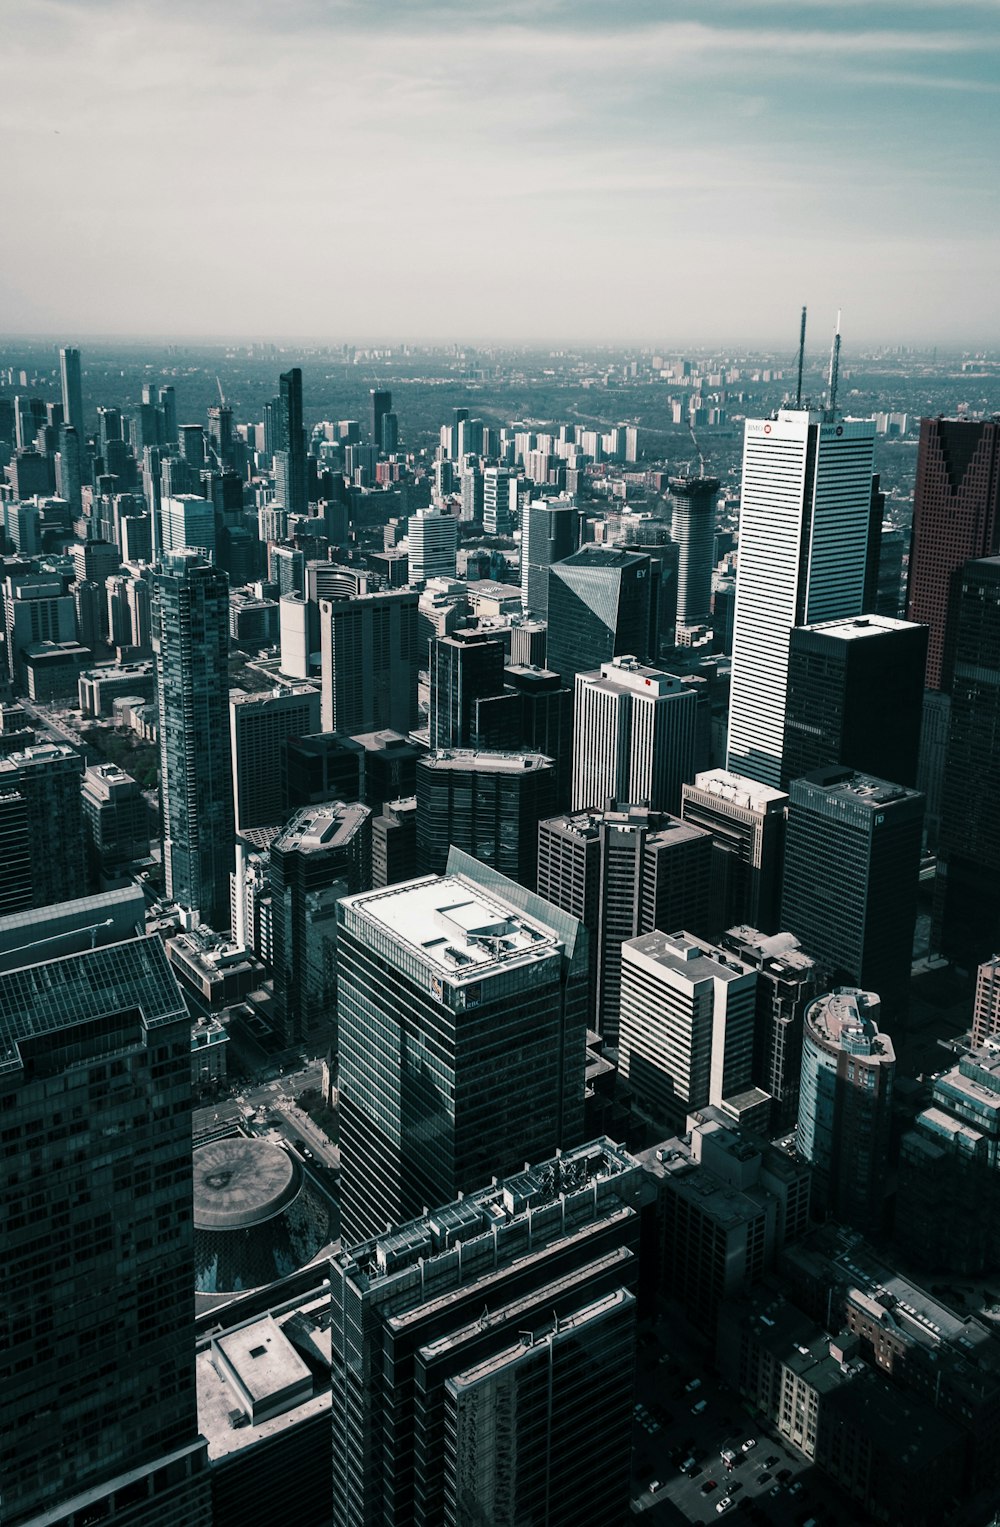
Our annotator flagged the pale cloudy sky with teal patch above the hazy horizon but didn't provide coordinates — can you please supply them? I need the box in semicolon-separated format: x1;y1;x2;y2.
0;0;1000;350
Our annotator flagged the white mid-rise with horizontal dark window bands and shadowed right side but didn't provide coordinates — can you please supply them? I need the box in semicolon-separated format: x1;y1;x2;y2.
618;930;757;1125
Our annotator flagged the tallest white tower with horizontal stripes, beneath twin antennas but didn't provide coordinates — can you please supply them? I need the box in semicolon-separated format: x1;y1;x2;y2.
728;409;875;788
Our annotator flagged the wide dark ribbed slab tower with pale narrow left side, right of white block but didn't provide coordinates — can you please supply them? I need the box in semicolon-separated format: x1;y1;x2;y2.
319;589;420;734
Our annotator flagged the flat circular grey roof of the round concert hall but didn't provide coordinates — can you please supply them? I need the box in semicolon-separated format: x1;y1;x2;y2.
194;1136;302;1231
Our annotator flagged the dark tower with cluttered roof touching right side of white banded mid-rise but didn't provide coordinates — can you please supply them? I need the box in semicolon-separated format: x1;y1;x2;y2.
719;927;820;1135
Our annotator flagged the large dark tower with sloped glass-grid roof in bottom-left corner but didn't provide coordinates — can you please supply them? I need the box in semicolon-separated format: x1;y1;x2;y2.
0;938;212;1527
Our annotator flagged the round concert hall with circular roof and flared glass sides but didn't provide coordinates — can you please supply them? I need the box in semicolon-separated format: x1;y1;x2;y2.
194;1136;330;1293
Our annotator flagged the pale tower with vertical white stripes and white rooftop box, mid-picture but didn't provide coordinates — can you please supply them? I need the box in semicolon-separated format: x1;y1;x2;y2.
573;657;698;812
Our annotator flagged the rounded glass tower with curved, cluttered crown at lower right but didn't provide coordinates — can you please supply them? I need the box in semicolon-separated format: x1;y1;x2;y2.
795;986;896;1234
